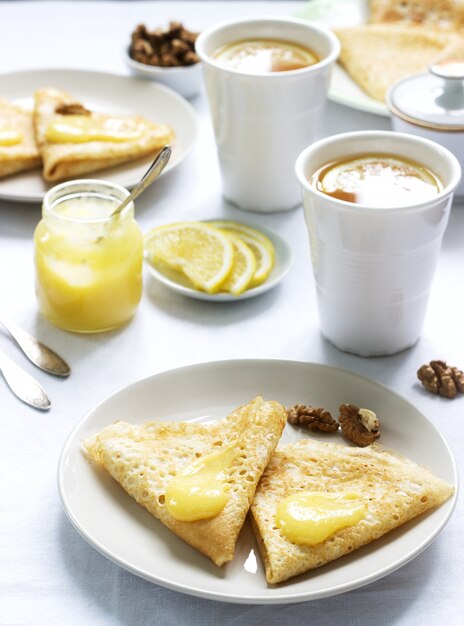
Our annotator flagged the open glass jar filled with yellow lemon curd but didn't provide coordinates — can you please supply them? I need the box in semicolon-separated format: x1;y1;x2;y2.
34;180;143;333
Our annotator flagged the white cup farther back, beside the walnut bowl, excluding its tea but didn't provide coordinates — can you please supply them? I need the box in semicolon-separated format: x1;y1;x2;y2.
196;17;340;212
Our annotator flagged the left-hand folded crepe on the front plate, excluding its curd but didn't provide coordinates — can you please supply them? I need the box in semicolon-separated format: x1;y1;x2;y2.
84;397;286;566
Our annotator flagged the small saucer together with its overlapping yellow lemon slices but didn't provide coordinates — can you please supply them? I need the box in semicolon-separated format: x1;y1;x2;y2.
144;220;291;302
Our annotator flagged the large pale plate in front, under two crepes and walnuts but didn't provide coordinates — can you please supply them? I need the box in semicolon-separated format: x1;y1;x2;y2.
58;360;457;604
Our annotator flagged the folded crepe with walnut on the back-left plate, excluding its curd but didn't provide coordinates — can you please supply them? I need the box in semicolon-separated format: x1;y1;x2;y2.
34;88;174;181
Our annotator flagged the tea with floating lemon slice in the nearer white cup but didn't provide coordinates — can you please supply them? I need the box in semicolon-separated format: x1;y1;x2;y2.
310;154;443;208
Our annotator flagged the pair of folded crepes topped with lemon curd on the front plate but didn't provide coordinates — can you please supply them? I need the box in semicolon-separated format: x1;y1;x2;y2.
83;396;454;583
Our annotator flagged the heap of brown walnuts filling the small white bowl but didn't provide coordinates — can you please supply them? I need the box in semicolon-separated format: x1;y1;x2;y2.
129;22;200;67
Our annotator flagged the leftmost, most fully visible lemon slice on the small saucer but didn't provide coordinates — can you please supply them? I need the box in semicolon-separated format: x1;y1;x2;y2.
144;222;234;293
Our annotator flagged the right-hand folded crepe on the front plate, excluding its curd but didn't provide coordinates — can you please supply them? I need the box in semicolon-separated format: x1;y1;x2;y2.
251;439;453;583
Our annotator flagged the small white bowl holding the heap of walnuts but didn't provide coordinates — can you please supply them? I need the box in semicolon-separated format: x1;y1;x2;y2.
125;48;202;98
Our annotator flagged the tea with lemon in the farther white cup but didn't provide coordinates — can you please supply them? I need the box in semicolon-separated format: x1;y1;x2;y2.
213;39;320;74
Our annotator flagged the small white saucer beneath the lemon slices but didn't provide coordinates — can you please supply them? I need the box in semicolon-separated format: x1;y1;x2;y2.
145;220;292;302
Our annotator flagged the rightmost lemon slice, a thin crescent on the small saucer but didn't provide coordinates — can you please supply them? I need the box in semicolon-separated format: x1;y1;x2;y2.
210;220;275;289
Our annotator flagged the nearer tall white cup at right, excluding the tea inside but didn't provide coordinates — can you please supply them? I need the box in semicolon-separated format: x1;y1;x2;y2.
296;131;461;356
